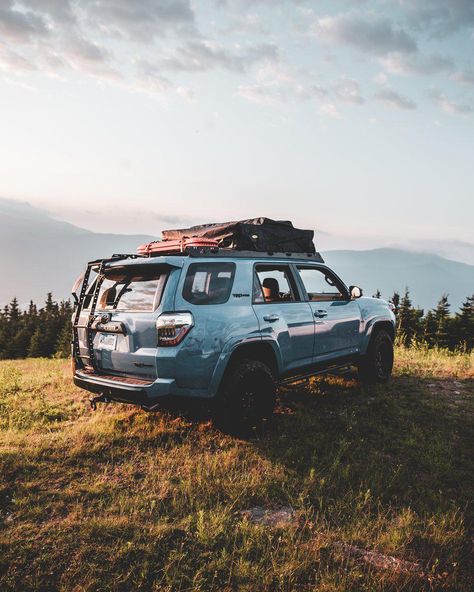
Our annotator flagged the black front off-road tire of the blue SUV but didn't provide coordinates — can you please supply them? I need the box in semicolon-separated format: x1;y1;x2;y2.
359;329;393;384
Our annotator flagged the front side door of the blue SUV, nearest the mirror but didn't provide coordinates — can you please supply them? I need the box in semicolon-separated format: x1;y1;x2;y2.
295;265;361;362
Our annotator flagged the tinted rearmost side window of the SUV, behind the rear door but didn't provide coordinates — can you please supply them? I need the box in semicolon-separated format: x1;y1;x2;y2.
183;263;235;304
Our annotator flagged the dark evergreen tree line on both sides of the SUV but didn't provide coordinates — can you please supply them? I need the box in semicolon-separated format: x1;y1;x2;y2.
0;289;474;359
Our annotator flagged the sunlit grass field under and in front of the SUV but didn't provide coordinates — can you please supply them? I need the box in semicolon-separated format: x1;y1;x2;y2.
0;349;474;592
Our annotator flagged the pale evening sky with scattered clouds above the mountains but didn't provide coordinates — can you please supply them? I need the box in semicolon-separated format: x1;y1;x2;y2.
0;0;474;243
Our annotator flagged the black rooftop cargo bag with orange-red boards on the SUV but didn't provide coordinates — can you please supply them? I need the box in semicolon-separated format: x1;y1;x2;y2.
163;218;316;254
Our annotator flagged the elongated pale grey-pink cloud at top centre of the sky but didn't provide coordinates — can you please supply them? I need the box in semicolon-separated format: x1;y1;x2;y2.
161;41;278;72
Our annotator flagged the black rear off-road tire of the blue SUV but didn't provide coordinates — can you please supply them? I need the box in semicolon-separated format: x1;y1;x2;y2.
214;360;276;430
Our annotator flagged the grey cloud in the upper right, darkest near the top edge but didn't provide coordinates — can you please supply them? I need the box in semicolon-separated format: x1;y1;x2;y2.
313;14;417;56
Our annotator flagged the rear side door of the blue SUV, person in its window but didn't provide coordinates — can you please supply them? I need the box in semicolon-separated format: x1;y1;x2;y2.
253;263;314;372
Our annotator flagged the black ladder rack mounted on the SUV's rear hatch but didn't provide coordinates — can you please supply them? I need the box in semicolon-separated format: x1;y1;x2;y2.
72;254;141;372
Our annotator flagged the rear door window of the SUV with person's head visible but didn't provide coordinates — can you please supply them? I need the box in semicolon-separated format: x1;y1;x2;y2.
254;265;300;304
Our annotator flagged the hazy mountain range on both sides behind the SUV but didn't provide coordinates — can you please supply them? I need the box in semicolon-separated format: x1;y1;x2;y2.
0;198;474;310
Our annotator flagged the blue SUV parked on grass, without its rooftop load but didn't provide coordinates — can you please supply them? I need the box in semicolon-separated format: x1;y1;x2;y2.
73;248;395;424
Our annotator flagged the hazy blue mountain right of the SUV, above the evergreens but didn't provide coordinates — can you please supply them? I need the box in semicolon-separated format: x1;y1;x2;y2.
323;248;474;310
